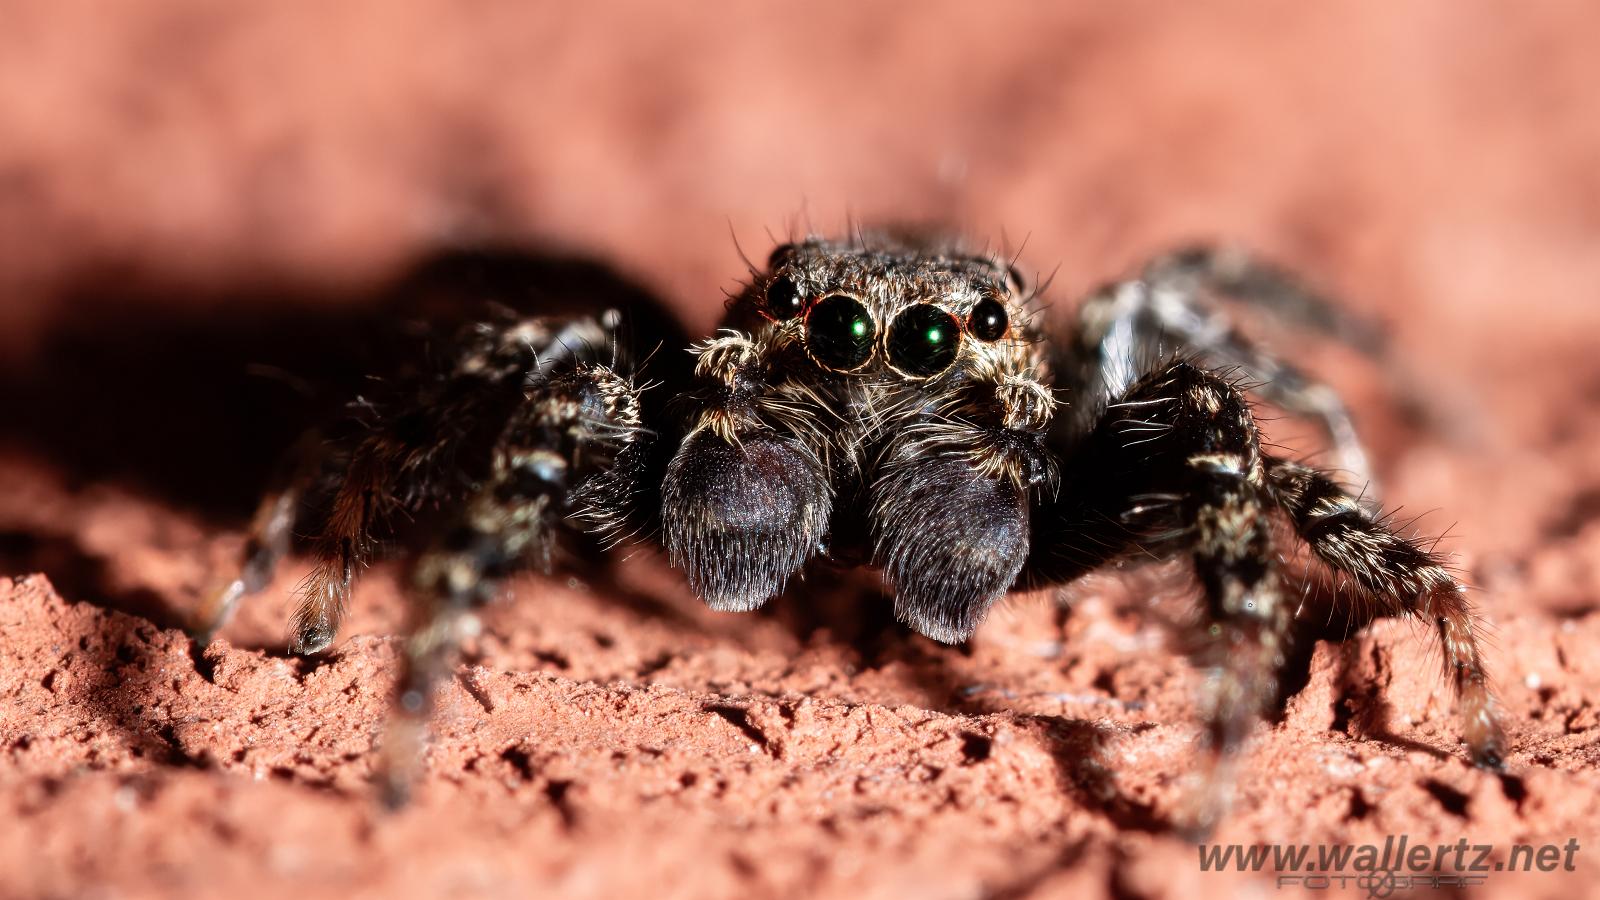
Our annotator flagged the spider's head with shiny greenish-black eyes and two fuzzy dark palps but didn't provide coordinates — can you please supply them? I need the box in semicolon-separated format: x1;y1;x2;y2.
661;237;1054;641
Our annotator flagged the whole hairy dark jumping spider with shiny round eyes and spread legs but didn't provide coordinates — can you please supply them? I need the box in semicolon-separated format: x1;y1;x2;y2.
198;232;1506;822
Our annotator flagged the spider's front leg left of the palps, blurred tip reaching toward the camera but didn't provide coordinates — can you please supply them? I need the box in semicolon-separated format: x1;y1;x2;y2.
379;364;650;806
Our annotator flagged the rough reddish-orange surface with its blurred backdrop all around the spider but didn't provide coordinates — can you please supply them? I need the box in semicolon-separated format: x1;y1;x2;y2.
0;0;1600;897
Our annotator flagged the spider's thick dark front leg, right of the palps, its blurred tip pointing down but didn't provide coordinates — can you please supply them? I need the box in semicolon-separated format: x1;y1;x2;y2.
1021;355;1293;828
